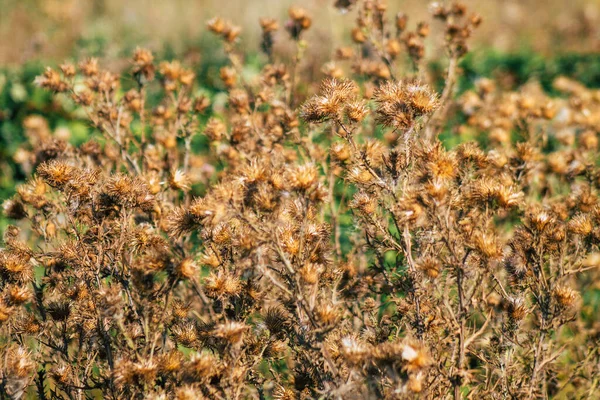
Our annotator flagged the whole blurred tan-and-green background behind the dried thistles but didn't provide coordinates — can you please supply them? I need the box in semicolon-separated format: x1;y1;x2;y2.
0;0;600;211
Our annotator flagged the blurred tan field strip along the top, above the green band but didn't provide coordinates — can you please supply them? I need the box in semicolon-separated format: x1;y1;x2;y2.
0;0;600;65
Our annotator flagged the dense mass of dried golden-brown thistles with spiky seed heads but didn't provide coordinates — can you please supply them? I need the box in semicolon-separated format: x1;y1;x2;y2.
0;0;600;399
